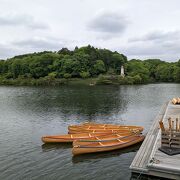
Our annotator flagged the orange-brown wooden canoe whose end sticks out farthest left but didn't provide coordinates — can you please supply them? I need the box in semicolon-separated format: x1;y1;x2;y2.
41;132;113;143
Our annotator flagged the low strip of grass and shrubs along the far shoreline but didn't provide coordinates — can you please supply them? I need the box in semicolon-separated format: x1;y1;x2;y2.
0;75;152;86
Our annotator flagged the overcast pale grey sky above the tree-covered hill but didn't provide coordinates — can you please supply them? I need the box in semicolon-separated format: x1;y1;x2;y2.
0;0;180;61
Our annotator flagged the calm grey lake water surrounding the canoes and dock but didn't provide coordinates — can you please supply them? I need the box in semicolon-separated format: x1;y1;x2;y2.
0;84;180;180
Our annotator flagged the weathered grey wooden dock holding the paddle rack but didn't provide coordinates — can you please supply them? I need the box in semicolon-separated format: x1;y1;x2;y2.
130;102;180;179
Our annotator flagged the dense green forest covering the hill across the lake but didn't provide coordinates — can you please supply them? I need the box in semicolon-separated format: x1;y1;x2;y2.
0;45;180;85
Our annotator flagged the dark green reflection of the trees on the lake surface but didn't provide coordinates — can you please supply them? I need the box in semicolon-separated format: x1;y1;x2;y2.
10;86;127;119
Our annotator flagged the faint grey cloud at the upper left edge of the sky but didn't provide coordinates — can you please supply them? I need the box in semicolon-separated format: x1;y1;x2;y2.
0;14;49;29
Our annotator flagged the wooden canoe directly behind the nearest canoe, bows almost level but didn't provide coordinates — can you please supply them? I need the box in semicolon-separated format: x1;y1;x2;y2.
73;133;141;146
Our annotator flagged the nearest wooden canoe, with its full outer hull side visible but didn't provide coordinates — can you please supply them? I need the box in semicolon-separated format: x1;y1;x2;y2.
72;135;144;155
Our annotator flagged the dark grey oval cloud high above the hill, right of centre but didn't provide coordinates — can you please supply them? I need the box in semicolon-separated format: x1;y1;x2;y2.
88;12;128;34
